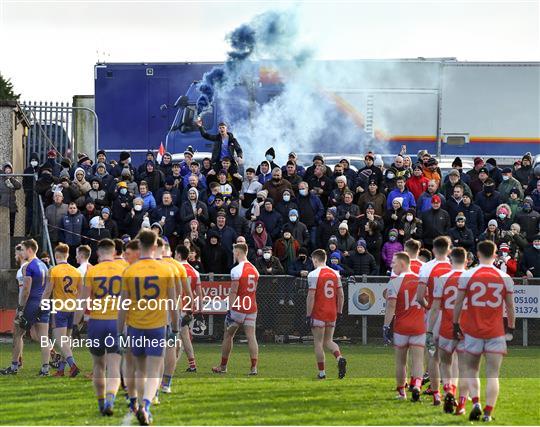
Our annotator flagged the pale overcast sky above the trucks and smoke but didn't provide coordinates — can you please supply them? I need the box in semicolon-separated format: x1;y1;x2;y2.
0;0;540;101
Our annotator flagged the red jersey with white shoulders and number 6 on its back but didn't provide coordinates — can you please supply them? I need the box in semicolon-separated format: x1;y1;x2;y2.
308;267;341;322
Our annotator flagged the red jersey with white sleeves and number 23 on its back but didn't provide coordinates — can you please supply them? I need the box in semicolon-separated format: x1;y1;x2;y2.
458;264;514;339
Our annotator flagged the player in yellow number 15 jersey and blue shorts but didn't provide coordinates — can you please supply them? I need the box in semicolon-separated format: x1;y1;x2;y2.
118;230;178;425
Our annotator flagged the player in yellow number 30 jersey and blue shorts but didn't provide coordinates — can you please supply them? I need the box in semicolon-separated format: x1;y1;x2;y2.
75;239;125;416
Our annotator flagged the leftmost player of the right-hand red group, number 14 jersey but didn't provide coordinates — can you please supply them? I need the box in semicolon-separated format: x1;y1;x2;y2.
383;252;426;402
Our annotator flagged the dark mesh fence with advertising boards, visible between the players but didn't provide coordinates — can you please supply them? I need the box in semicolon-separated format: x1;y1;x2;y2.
195;274;540;346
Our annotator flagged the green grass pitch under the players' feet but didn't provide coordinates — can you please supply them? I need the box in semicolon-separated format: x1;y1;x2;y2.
0;344;540;425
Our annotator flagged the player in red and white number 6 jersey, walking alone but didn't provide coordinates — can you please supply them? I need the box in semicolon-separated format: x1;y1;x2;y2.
306;249;347;380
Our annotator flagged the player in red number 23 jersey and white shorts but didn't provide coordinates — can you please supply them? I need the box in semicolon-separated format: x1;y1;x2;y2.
453;240;515;421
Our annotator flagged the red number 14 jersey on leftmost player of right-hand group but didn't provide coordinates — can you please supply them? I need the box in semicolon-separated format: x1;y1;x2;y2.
386;272;426;335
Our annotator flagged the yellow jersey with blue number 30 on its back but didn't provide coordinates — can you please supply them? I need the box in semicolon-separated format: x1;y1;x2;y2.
84;260;125;320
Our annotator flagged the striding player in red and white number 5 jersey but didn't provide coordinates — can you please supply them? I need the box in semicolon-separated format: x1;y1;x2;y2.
212;243;259;375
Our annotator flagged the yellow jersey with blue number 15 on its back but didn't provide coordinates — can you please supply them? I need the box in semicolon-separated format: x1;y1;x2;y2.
122;258;175;329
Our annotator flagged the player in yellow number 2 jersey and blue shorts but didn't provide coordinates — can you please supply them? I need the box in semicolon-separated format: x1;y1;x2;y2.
42;243;82;377
